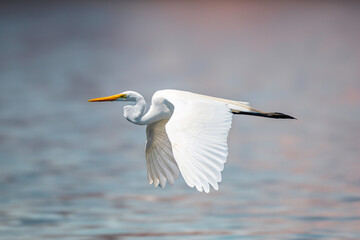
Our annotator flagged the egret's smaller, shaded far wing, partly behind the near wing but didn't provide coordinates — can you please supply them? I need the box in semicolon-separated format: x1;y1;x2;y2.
145;119;179;187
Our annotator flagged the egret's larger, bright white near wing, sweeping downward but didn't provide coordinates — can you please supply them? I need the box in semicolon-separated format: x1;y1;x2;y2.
166;92;232;192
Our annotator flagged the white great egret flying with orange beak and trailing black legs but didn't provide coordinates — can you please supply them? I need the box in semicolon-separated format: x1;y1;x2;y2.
89;90;294;193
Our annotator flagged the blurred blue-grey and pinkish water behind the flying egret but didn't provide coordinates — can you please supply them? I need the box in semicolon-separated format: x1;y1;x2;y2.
0;1;360;240
